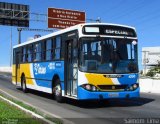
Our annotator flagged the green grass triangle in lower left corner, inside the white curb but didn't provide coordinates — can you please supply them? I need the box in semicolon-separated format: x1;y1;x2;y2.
0;99;44;124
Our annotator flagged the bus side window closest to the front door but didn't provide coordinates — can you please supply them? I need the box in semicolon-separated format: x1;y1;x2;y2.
55;37;61;59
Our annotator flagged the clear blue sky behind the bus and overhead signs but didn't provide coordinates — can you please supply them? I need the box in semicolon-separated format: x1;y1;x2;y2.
0;0;160;69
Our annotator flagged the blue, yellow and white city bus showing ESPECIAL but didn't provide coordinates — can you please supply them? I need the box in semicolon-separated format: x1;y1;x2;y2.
12;23;140;102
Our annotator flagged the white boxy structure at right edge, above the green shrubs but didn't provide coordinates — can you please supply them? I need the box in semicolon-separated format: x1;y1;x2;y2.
142;46;160;66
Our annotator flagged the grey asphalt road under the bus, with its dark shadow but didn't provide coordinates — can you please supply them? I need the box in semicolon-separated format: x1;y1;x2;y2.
0;74;160;124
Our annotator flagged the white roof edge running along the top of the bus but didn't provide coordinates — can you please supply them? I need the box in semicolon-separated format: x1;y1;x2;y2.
13;23;135;48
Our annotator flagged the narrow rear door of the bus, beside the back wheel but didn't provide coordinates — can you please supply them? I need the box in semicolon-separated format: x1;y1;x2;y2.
15;51;21;85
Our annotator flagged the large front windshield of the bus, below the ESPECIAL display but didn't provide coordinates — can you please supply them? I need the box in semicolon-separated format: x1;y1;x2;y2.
79;38;138;74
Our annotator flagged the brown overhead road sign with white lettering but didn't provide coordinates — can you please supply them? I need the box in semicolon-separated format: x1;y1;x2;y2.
48;8;85;29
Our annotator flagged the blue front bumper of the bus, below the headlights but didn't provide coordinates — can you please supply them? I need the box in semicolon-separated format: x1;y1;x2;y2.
78;87;140;100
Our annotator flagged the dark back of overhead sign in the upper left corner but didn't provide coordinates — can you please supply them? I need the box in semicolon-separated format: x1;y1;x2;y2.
0;2;29;27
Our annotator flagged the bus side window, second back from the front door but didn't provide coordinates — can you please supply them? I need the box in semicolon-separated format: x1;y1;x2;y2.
46;39;52;60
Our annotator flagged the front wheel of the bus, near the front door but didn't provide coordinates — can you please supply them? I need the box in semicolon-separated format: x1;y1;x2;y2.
54;79;63;103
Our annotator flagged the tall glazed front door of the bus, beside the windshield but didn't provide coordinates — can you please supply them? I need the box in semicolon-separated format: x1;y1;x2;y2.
65;39;78;97
